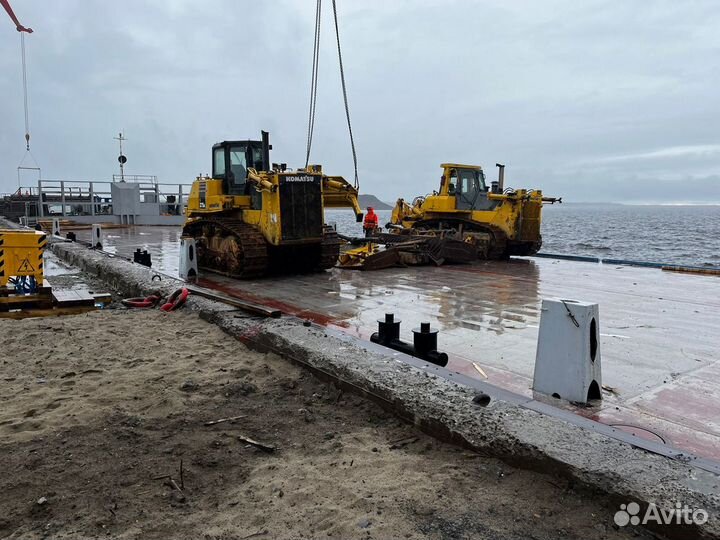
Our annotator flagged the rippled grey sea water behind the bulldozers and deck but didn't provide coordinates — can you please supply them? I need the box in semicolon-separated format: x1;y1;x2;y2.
326;203;720;266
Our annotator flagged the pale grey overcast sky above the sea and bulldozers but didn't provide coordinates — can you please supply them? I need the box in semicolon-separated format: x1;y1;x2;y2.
0;0;720;203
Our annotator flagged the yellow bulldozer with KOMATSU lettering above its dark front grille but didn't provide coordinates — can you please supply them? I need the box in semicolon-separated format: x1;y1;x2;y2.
183;131;362;278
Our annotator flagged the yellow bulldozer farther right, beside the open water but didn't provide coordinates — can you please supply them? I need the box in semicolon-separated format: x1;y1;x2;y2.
387;163;562;259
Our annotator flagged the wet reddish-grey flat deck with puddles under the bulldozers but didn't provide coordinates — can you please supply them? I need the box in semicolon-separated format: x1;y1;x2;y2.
69;227;720;460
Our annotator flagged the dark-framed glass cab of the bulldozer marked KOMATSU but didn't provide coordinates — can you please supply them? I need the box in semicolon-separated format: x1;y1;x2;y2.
212;131;272;195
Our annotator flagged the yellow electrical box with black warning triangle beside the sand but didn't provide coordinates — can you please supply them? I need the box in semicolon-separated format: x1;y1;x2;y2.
0;229;47;287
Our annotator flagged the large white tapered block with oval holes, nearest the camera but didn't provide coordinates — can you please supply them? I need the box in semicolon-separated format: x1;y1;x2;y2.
533;299;602;403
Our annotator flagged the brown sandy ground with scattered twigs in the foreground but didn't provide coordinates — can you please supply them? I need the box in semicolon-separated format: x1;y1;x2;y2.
0;309;652;539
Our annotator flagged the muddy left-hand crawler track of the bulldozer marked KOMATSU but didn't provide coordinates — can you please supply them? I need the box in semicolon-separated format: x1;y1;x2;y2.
183;218;268;279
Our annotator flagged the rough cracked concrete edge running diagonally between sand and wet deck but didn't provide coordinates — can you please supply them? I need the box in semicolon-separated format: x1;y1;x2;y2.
51;238;720;538
